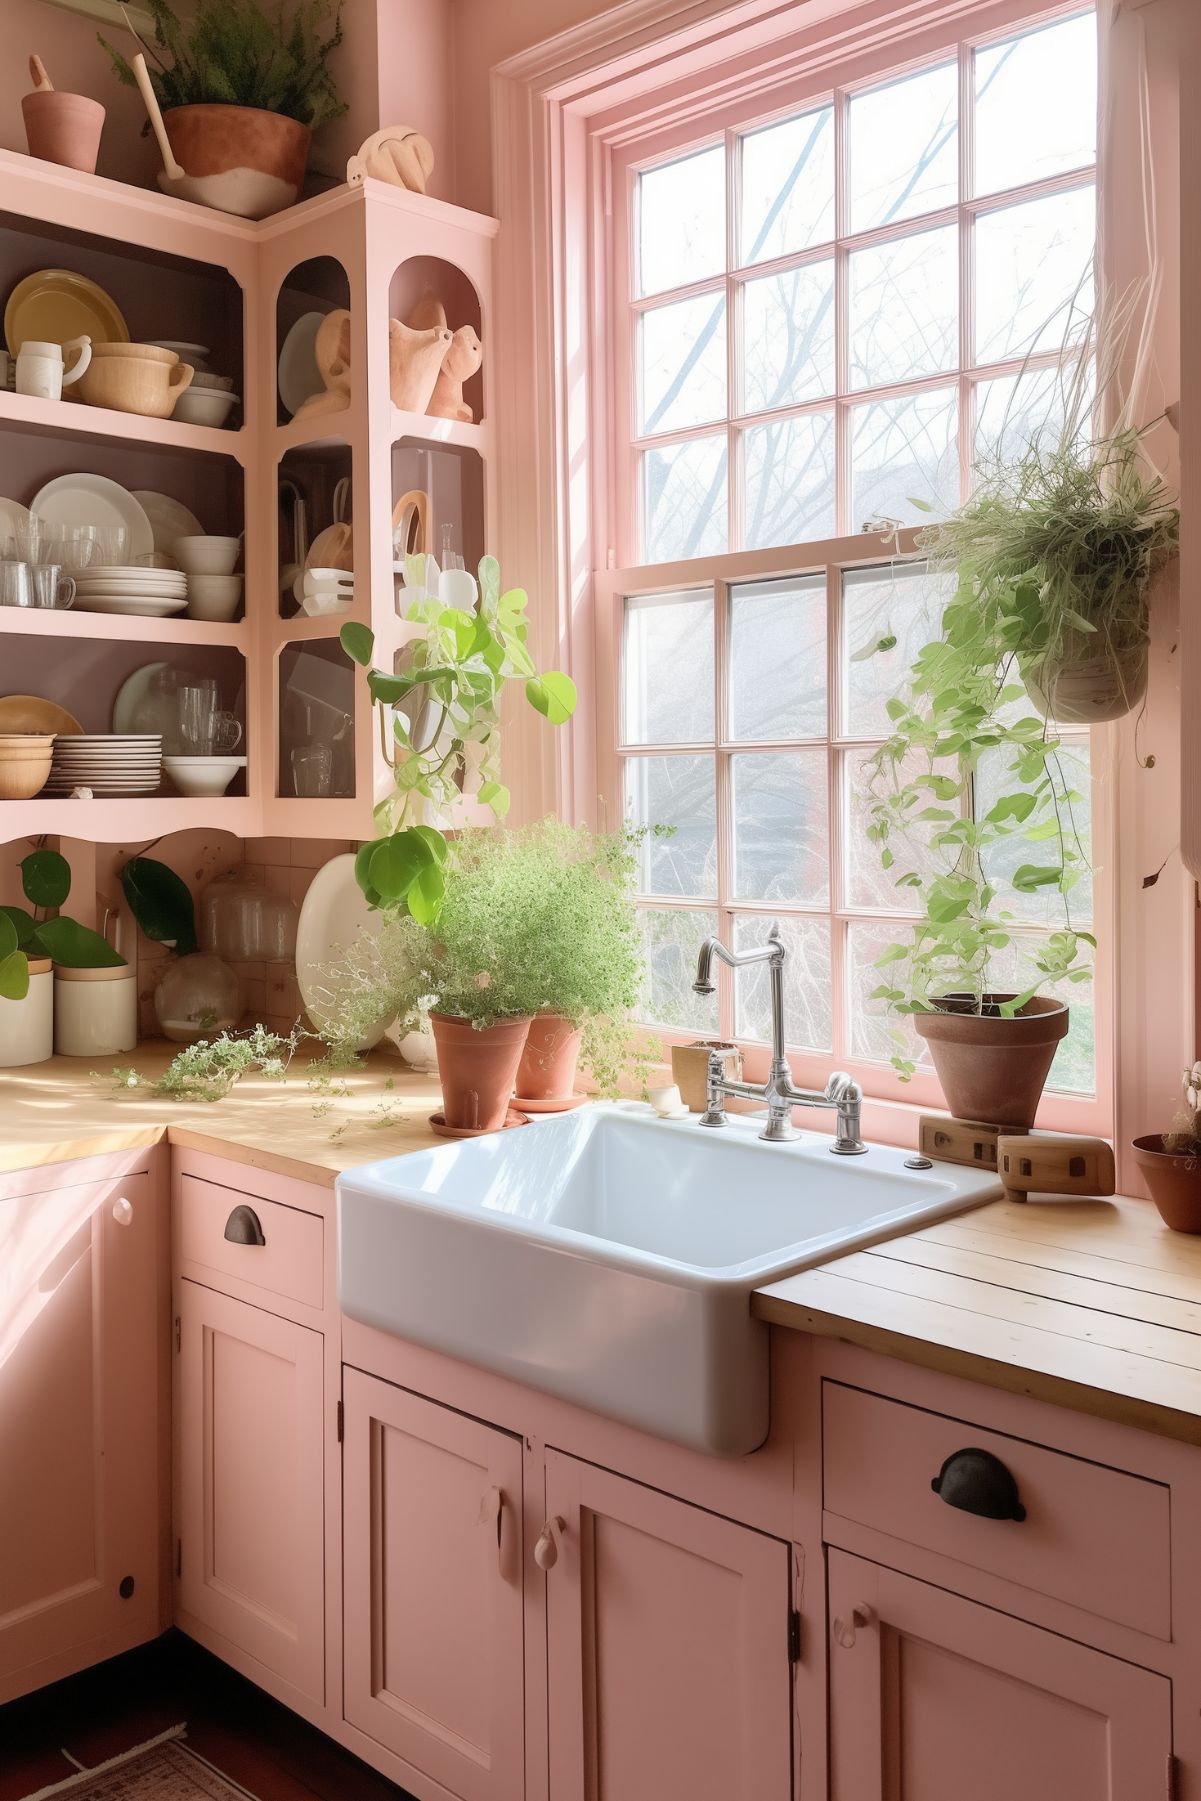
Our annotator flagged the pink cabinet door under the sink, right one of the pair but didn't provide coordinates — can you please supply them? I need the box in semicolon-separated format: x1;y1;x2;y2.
538;1452;792;1801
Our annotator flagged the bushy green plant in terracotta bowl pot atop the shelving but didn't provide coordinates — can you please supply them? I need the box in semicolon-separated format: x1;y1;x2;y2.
99;0;346;216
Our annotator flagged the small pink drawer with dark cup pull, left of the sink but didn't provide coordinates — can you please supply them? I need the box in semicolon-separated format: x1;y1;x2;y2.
175;1176;326;1308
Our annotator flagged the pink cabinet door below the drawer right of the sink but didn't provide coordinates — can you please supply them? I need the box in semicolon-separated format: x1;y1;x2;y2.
830;1551;1172;1801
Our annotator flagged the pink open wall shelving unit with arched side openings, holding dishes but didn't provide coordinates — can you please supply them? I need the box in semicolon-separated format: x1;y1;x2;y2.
0;151;497;843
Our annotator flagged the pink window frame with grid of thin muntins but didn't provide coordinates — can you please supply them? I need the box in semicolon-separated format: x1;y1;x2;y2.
592;0;1115;1142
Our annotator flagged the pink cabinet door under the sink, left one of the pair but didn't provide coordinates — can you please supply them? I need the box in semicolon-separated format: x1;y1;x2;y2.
342;1369;526;1801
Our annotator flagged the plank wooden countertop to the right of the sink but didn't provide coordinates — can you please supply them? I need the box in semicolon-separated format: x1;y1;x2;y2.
753;1198;1201;1444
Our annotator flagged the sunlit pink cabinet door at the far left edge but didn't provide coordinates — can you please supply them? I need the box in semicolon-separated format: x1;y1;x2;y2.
0;1174;162;1698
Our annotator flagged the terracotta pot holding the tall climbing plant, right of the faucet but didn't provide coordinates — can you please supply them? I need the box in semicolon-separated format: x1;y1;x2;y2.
913;994;1068;1131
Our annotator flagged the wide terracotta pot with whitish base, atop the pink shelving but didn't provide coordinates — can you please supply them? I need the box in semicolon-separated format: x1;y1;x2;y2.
162;106;312;218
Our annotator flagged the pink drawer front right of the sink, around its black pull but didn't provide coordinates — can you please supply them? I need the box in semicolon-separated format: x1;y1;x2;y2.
821;1381;1172;1639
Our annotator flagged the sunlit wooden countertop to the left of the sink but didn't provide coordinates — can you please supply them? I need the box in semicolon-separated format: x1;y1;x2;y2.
0;1041;441;1187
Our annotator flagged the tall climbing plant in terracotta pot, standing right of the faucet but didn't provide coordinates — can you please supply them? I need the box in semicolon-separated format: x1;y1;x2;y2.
864;569;1095;1129
